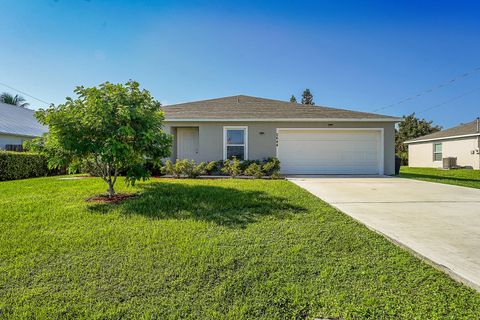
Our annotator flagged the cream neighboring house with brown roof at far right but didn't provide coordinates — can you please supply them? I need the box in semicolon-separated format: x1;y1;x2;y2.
405;119;480;169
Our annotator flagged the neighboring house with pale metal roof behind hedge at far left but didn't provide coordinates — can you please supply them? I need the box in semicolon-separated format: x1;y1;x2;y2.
0;102;48;150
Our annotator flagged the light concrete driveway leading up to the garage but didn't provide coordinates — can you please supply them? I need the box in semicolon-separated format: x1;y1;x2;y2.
288;176;480;291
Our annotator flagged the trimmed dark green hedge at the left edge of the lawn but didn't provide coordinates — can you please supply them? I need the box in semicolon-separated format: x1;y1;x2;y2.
0;151;49;181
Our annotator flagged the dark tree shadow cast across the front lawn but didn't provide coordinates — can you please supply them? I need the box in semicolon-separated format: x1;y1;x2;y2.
89;182;307;227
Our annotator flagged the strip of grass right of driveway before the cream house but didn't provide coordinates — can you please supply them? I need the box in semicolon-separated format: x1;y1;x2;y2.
400;167;480;189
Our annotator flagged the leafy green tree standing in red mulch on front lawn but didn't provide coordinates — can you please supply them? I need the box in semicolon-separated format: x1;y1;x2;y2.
31;81;171;197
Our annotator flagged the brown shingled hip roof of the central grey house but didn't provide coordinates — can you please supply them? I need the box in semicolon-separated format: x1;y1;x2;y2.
163;95;401;122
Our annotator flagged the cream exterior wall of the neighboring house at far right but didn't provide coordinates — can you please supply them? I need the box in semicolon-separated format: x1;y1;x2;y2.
408;137;480;169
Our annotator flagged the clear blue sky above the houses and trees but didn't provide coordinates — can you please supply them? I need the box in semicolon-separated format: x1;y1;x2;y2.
0;0;480;127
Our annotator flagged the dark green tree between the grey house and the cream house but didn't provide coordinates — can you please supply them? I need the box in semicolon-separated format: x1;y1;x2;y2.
395;113;442;164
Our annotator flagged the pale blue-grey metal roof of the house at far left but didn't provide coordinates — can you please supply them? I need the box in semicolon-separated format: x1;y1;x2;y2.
0;102;48;137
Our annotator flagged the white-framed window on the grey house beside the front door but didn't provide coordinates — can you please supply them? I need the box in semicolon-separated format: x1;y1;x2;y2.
223;127;248;160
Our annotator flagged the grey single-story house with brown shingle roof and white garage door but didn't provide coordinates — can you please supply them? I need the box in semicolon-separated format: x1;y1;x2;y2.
163;95;401;175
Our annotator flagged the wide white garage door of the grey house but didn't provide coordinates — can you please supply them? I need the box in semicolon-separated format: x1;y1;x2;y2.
277;129;383;174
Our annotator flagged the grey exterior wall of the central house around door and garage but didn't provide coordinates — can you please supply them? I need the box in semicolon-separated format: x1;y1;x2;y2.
165;121;395;175
